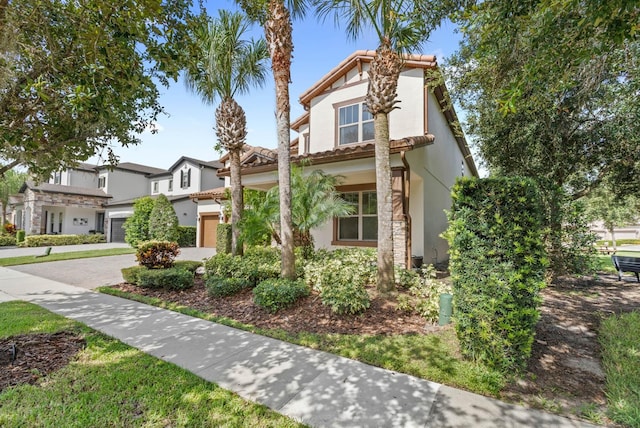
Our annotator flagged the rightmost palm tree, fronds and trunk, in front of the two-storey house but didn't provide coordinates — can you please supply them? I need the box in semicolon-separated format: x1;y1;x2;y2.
316;0;439;292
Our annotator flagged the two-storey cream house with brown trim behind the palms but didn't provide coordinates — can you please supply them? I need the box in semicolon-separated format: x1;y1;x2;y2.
192;51;478;266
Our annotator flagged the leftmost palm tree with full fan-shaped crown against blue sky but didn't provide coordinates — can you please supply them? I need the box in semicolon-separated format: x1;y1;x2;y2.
186;10;269;255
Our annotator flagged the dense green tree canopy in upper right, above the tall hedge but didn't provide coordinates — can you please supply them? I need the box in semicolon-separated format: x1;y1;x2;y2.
450;0;640;199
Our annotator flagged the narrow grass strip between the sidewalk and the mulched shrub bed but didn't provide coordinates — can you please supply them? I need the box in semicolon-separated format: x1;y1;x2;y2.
98;287;507;397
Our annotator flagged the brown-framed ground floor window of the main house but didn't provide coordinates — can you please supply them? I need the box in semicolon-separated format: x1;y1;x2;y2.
334;190;378;244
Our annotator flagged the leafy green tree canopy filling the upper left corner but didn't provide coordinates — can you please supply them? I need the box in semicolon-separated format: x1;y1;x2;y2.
0;0;197;176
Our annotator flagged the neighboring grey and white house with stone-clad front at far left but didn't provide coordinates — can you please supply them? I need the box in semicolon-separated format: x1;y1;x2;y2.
11;156;224;242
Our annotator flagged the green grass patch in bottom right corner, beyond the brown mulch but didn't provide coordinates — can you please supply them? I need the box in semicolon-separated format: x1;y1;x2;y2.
600;312;640;427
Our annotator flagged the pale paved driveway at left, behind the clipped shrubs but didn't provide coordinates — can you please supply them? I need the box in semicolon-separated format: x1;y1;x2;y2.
0;244;216;289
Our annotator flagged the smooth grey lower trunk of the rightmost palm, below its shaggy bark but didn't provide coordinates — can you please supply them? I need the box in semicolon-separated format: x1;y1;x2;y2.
373;112;394;293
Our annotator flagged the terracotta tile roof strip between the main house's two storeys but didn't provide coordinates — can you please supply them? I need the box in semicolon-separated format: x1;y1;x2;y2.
218;134;435;176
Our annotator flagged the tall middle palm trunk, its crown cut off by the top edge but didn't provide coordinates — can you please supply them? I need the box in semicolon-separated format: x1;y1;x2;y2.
265;0;295;279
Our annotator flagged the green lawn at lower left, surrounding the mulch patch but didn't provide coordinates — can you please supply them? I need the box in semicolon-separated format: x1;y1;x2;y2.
0;302;303;427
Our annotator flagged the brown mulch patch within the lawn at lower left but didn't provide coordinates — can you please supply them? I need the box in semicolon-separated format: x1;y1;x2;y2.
0;331;85;392
